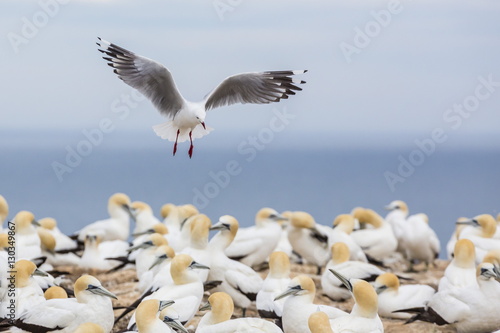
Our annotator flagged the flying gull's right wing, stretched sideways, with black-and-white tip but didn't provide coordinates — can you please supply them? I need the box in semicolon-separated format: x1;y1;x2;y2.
205;70;307;111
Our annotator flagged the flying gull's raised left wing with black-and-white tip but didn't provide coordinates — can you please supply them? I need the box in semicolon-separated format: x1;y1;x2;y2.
97;37;185;118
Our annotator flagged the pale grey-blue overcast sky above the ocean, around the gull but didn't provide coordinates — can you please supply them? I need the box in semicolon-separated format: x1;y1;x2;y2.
0;0;500;147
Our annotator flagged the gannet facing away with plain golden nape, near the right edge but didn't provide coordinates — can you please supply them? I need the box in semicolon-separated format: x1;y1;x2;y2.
438;239;477;291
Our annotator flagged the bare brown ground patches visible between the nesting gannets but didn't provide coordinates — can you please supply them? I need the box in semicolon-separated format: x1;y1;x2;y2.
55;261;455;333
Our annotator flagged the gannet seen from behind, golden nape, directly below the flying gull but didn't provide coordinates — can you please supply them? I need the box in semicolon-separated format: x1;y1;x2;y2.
180;214;212;282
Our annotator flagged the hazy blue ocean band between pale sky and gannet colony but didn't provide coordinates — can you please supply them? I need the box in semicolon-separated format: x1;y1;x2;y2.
0;133;500;257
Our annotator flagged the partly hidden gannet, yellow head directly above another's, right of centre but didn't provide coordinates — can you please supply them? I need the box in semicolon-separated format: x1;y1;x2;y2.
328;214;368;262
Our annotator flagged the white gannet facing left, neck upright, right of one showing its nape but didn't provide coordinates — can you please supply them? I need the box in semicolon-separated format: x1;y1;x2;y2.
208;215;263;316
